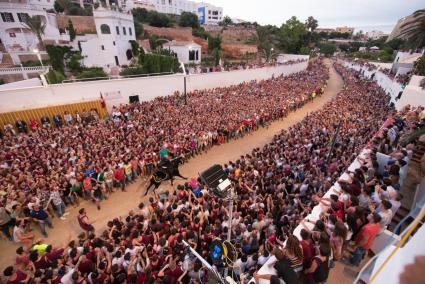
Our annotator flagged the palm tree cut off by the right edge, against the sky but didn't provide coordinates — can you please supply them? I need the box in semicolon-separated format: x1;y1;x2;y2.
398;9;425;47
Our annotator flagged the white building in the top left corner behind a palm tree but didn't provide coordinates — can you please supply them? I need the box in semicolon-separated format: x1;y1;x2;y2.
0;0;69;65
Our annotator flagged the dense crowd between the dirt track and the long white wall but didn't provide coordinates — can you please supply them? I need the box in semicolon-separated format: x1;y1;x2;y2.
0;61;328;235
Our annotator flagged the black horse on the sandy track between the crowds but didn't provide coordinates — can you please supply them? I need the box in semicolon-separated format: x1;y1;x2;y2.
145;157;187;196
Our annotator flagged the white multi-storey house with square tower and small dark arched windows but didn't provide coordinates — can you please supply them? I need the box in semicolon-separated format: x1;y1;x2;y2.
80;7;136;68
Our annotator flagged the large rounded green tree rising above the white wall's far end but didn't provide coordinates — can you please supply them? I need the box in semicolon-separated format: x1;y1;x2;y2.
280;16;308;53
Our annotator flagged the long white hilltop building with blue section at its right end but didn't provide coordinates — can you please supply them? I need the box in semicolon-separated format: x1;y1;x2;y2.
142;0;223;25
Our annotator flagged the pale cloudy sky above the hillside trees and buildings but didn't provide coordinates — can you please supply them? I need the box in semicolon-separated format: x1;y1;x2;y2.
204;0;425;33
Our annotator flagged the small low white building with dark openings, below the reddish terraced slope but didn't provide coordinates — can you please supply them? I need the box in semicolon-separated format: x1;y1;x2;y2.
162;40;202;64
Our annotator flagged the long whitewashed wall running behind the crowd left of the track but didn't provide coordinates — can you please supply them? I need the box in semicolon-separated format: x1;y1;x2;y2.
0;62;308;112
